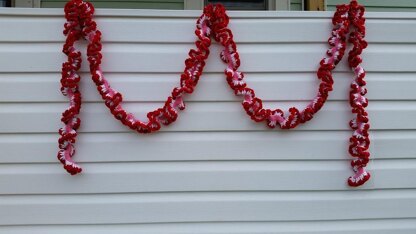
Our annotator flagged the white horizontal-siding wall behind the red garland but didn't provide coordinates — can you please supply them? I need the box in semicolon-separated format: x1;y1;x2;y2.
0;9;416;234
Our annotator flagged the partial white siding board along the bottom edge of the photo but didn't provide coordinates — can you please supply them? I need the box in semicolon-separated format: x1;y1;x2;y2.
0;219;416;234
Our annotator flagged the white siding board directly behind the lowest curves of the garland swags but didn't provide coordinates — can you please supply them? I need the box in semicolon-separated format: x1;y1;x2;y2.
0;101;416;133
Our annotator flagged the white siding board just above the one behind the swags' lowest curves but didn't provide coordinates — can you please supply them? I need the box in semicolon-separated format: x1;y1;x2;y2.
0;72;416;103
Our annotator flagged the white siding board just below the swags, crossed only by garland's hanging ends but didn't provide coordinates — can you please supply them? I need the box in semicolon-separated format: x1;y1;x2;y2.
0;131;416;163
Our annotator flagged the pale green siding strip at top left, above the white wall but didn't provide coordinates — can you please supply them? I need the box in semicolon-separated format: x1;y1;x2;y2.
41;0;184;10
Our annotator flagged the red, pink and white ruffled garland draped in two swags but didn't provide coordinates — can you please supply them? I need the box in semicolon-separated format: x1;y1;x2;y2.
58;0;370;187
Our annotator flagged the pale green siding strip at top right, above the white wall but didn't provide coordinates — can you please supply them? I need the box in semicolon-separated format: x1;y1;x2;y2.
326;0;416;12
